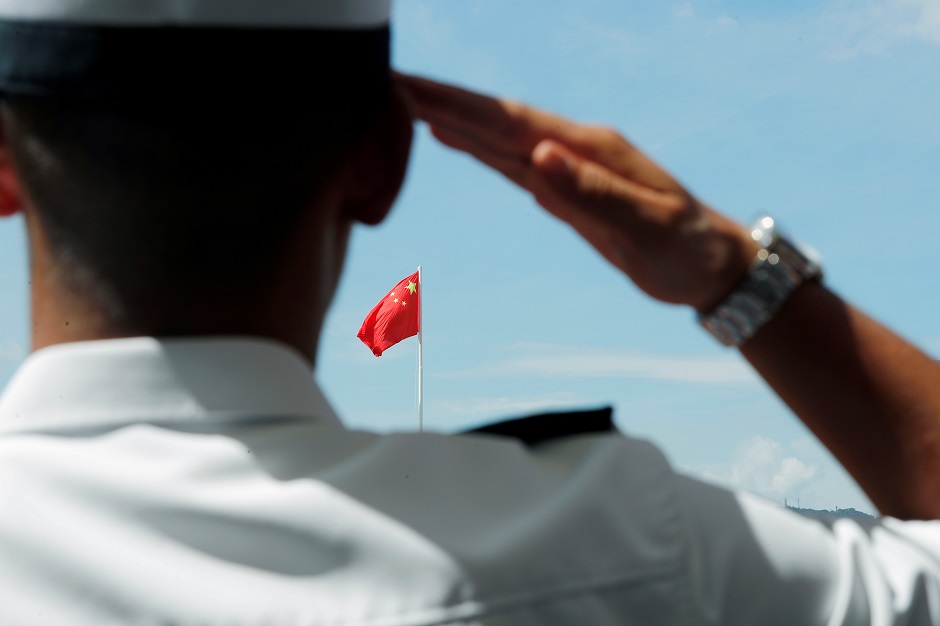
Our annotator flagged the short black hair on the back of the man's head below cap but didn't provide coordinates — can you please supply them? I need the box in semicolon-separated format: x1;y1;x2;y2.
2;86;387;334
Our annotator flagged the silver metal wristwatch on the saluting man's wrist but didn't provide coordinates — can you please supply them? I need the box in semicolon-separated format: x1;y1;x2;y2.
698;216;822;346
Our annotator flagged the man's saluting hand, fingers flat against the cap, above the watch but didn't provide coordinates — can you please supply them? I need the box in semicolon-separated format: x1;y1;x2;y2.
397;74;757;311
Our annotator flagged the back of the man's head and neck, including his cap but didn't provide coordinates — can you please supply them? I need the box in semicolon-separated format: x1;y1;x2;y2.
0;0;411;354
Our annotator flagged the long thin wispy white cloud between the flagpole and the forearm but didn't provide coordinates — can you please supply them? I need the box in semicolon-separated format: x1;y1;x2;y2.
442;343;758;385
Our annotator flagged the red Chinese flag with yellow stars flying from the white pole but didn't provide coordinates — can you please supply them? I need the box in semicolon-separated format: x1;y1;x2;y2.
358;272;421;356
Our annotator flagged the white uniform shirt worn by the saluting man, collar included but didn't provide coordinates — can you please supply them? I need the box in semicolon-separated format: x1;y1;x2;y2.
0;338;940;626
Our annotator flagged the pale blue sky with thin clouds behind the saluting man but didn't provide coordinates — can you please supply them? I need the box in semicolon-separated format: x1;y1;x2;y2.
0;0;940;512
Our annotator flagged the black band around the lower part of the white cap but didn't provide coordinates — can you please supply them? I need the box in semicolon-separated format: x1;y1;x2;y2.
0;20;390;106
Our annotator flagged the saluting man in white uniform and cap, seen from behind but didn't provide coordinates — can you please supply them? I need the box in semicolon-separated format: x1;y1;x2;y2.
0;0;940;626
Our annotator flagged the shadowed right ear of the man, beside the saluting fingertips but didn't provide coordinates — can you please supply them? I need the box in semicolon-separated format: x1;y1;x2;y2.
344;83;414;226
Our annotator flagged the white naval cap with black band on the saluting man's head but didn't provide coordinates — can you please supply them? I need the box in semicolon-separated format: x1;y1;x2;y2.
0;0;391;103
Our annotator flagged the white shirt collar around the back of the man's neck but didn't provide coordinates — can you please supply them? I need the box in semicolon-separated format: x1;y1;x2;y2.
0;337;339;433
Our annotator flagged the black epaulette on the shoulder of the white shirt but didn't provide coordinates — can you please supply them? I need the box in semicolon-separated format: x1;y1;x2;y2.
464;406;617;447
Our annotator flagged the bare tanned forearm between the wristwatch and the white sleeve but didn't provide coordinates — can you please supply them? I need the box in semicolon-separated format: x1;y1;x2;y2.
741;283;940;519
